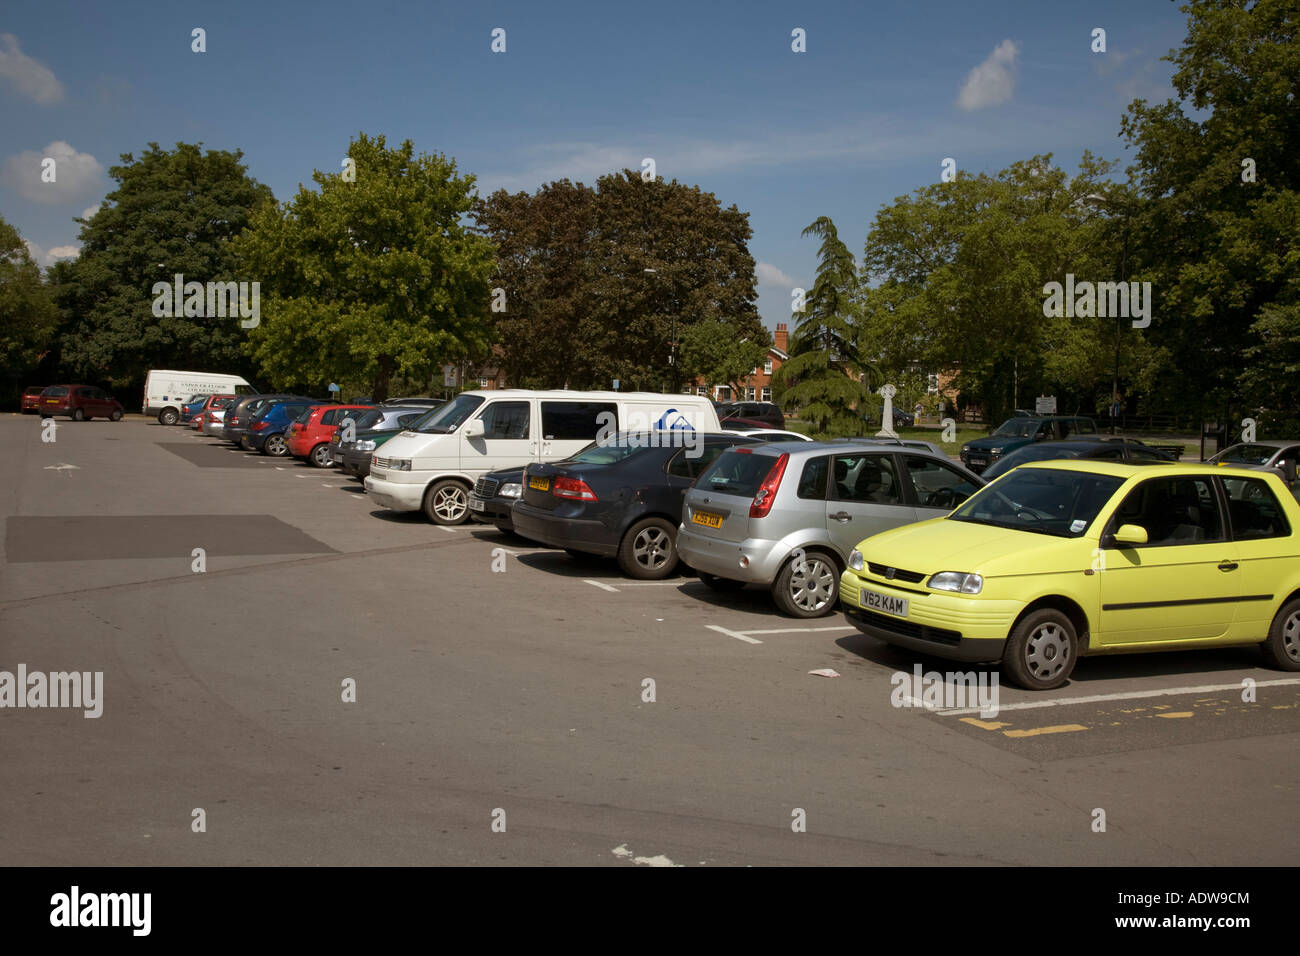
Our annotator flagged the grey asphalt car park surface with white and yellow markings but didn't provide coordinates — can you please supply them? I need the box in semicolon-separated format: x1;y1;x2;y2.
0;415;1300;866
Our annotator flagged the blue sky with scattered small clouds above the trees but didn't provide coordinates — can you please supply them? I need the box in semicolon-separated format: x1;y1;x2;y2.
0;0;1184;328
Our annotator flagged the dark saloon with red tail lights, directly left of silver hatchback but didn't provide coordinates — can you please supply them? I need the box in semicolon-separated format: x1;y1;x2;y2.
511;432;751;580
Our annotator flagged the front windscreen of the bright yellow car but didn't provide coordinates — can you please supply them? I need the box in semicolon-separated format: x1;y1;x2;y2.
948;468;1125;537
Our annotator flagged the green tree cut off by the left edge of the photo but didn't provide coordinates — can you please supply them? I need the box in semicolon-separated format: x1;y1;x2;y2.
0;219;59;388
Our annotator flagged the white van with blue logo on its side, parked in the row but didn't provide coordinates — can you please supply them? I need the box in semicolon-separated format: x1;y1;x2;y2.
365;389;720;524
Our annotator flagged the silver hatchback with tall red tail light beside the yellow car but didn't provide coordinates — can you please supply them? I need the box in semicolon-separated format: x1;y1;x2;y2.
677;442;985;618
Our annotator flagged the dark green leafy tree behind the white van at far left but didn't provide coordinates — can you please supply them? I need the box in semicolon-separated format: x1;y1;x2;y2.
51;143;272;386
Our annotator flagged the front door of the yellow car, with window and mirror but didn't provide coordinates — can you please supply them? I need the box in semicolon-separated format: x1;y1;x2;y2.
1097;473;1245;645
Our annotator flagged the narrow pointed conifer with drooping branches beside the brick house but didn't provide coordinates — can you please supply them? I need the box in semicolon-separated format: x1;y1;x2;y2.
772;216;880;434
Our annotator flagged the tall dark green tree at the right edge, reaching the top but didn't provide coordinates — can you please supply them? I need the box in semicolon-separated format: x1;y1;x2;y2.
1122;0;1300;425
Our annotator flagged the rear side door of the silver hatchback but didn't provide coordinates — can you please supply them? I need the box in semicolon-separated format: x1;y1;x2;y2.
826;451;917;554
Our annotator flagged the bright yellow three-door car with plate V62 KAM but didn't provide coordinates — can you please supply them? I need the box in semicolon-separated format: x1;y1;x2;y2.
840;460;1300;691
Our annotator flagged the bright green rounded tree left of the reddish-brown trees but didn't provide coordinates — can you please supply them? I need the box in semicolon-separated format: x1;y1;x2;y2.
235;134;493;399
